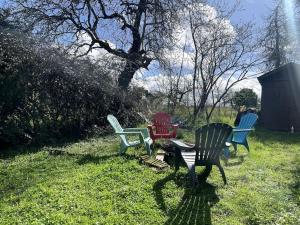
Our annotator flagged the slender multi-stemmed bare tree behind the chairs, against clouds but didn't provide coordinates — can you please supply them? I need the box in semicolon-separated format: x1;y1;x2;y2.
148;2;259;123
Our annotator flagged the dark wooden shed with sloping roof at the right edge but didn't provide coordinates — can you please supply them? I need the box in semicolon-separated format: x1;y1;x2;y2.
258;63;300;131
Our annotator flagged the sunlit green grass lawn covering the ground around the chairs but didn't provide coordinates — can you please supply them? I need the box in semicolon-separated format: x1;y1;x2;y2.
0;130;300;224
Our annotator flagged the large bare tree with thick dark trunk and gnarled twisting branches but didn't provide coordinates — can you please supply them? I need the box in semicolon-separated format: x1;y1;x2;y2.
14;0;188;89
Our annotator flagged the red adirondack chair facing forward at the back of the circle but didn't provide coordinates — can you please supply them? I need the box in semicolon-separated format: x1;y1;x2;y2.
148;112;178;143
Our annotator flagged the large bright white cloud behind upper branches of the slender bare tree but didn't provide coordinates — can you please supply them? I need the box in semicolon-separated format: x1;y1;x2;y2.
157;3;236;73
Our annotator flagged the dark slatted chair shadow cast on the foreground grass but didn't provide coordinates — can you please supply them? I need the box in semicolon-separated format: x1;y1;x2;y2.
153;173;219;225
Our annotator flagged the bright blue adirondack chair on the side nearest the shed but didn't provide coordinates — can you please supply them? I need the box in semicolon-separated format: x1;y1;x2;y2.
224;113;258;158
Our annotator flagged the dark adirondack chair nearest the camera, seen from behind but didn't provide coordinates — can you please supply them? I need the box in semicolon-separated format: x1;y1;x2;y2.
171;123;232;186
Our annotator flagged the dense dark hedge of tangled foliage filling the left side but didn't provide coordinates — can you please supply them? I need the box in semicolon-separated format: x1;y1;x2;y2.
0;29;145;144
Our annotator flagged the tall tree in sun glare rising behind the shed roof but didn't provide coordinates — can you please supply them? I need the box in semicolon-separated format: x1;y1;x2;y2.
261;0;300;70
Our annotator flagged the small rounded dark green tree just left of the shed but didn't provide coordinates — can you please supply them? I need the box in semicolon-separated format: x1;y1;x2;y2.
232;88;258;110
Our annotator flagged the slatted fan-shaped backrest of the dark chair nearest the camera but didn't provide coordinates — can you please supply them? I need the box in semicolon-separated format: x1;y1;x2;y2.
195;123;232;162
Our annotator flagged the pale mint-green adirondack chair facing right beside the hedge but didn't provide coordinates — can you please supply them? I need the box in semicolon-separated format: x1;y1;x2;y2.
107;115;153;155
